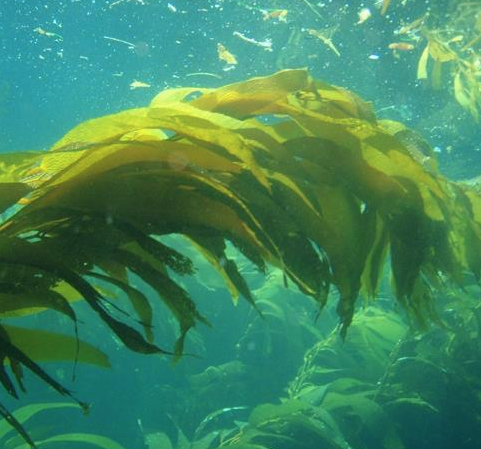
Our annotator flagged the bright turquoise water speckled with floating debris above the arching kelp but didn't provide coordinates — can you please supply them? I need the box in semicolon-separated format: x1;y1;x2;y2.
0;0;480;177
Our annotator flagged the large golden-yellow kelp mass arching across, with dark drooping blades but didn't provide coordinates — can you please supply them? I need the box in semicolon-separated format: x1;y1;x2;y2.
0;70;481;416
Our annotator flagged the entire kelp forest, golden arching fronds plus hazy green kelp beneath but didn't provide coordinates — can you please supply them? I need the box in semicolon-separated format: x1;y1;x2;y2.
0;67;481;449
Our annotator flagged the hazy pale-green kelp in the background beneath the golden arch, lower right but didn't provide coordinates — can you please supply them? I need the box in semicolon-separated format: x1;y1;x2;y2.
170;295;481;449
